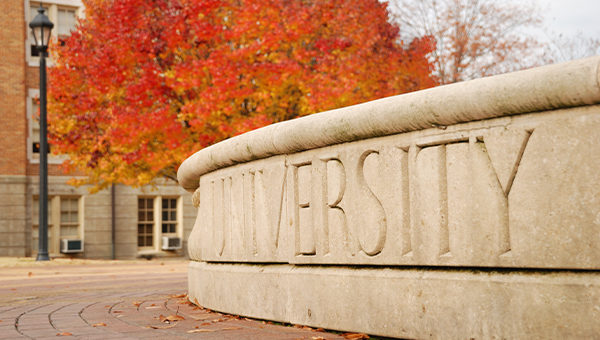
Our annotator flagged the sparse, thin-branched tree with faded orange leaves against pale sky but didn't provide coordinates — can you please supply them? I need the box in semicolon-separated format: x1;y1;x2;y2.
389;0;548;84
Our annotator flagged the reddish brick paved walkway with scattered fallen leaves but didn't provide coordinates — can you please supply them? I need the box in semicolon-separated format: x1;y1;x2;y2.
0;259;352;340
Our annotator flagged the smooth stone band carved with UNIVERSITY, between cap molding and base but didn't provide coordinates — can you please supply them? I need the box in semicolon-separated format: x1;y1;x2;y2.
192;112;600;269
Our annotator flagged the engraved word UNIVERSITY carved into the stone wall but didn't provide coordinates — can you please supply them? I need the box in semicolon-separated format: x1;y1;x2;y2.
202;128;531;265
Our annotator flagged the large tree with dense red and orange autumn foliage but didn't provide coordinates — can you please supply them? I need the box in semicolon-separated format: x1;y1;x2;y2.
49;0;435;190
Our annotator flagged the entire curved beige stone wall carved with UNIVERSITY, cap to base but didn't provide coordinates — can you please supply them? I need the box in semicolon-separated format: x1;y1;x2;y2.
178;56;600;339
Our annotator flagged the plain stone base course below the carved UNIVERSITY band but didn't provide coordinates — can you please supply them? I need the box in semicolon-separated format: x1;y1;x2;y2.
189;262;600;339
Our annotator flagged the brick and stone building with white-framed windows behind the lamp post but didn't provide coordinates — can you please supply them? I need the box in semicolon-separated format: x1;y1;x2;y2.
0;0;196;259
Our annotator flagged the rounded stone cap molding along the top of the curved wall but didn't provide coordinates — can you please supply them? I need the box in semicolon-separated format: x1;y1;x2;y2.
177;56;600;192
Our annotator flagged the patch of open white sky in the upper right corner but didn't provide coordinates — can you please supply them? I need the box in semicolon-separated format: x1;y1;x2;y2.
538;0;600;38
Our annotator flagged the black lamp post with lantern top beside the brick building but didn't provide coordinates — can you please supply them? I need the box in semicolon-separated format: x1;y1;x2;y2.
29;5;54;261
